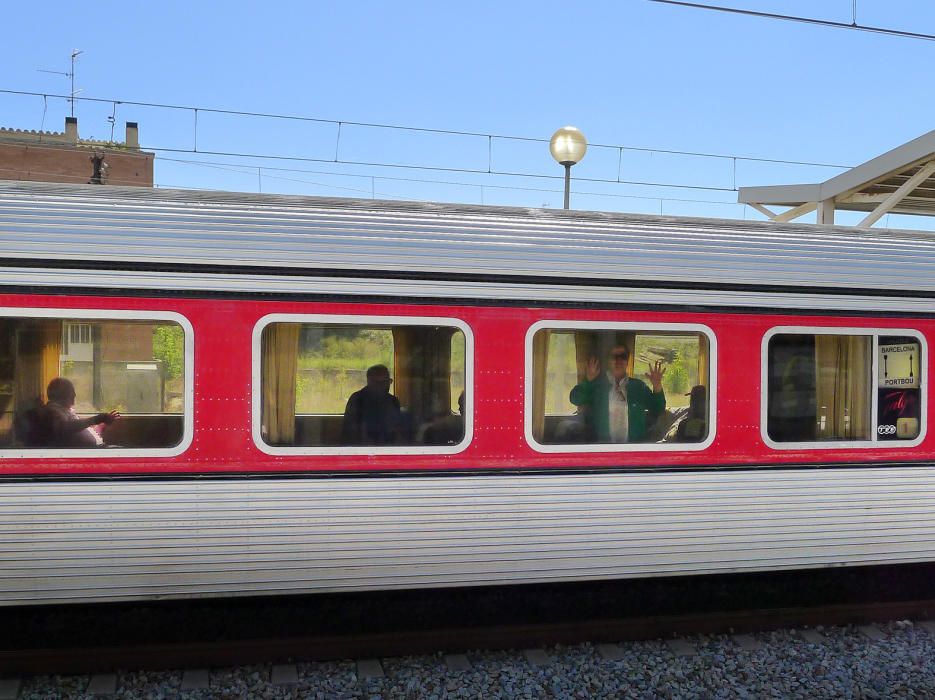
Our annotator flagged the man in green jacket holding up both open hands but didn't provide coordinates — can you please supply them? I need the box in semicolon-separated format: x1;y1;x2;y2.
569;345;666;443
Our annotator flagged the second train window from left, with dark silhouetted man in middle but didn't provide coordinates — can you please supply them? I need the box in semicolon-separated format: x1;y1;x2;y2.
254;314;473;454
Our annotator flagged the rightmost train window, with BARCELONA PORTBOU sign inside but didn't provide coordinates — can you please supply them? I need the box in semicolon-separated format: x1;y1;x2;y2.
763;329;926;447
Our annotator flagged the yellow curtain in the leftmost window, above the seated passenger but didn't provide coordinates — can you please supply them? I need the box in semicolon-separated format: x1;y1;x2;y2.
14;319;62;410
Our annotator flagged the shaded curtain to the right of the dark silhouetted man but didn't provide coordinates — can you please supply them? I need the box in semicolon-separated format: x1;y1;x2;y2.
392;326;455;427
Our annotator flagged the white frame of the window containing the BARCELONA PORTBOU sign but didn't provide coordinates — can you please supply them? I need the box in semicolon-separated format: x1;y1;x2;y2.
760;326;928;450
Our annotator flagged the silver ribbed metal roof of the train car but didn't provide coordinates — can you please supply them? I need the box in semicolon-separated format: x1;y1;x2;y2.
0;181;935;295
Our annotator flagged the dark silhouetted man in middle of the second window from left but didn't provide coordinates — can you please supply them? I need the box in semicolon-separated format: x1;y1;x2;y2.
341;365;403;445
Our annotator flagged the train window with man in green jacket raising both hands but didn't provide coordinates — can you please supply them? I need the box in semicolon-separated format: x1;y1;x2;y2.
526;321;715;452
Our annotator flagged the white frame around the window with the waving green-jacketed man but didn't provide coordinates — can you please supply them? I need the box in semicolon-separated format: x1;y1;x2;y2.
523;320;717;453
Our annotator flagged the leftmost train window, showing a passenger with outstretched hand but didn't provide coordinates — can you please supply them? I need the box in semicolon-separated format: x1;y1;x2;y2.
0;309;191;457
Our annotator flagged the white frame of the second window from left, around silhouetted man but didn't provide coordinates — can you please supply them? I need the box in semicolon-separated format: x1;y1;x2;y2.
251;314;474;456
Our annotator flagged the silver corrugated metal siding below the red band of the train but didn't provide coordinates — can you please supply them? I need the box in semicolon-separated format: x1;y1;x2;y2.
0;469;935;604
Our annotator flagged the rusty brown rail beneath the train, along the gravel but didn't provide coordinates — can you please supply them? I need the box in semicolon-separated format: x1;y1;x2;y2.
0;599;935;675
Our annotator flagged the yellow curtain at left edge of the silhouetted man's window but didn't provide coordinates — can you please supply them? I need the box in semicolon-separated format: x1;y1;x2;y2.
261;323;301;445
